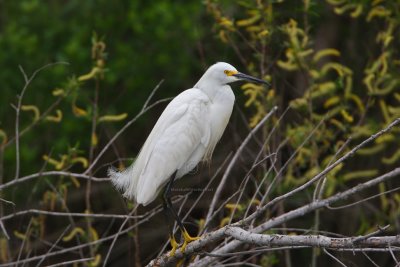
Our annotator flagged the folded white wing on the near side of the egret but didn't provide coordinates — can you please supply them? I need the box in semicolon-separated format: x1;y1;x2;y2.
112;89;210;205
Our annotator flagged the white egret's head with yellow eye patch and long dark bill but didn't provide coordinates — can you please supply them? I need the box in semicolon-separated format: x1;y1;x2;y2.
203;62;269;85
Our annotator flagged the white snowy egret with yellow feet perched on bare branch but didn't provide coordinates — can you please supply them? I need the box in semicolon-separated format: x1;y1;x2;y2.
109;62;268;255
